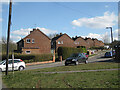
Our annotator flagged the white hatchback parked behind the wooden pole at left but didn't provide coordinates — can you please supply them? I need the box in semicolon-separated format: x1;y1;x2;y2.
0;59;26;71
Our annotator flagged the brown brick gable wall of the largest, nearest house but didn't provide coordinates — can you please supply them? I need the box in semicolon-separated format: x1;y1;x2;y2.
22;30;51;54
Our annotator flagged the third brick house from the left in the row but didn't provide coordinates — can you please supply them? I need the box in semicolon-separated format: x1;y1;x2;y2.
72;36;89;48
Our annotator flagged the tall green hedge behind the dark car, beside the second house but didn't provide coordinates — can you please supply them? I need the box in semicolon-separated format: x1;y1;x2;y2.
57;47;87;60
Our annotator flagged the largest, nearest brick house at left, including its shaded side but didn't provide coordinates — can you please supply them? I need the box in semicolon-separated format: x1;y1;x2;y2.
17;29;51;54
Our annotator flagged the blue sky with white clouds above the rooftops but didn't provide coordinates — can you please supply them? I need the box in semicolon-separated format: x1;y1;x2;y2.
0;2;118;42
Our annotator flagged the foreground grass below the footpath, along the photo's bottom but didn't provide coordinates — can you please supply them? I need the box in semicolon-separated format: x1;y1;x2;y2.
3;71;119;88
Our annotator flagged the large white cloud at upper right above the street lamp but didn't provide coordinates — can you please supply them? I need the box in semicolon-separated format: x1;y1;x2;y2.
72;11;118;29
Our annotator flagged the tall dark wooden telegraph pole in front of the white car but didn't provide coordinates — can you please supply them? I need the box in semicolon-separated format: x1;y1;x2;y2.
6;0;12;75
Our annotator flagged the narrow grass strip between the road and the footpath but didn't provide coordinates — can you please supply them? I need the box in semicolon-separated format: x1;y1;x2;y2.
26;62;118;72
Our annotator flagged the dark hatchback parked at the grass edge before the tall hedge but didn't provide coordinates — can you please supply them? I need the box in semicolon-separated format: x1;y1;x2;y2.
65;53;88;66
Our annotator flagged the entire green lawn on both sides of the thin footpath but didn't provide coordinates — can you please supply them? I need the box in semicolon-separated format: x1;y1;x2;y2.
3;63;119;88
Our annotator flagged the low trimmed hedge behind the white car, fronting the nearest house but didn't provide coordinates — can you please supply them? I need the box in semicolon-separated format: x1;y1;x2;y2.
2;53;53;63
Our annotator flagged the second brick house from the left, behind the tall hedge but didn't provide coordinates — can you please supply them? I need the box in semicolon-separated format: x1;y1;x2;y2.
51;33;74;51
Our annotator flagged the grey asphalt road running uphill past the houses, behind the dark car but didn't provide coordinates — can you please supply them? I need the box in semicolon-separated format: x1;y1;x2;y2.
25;52;112;70
